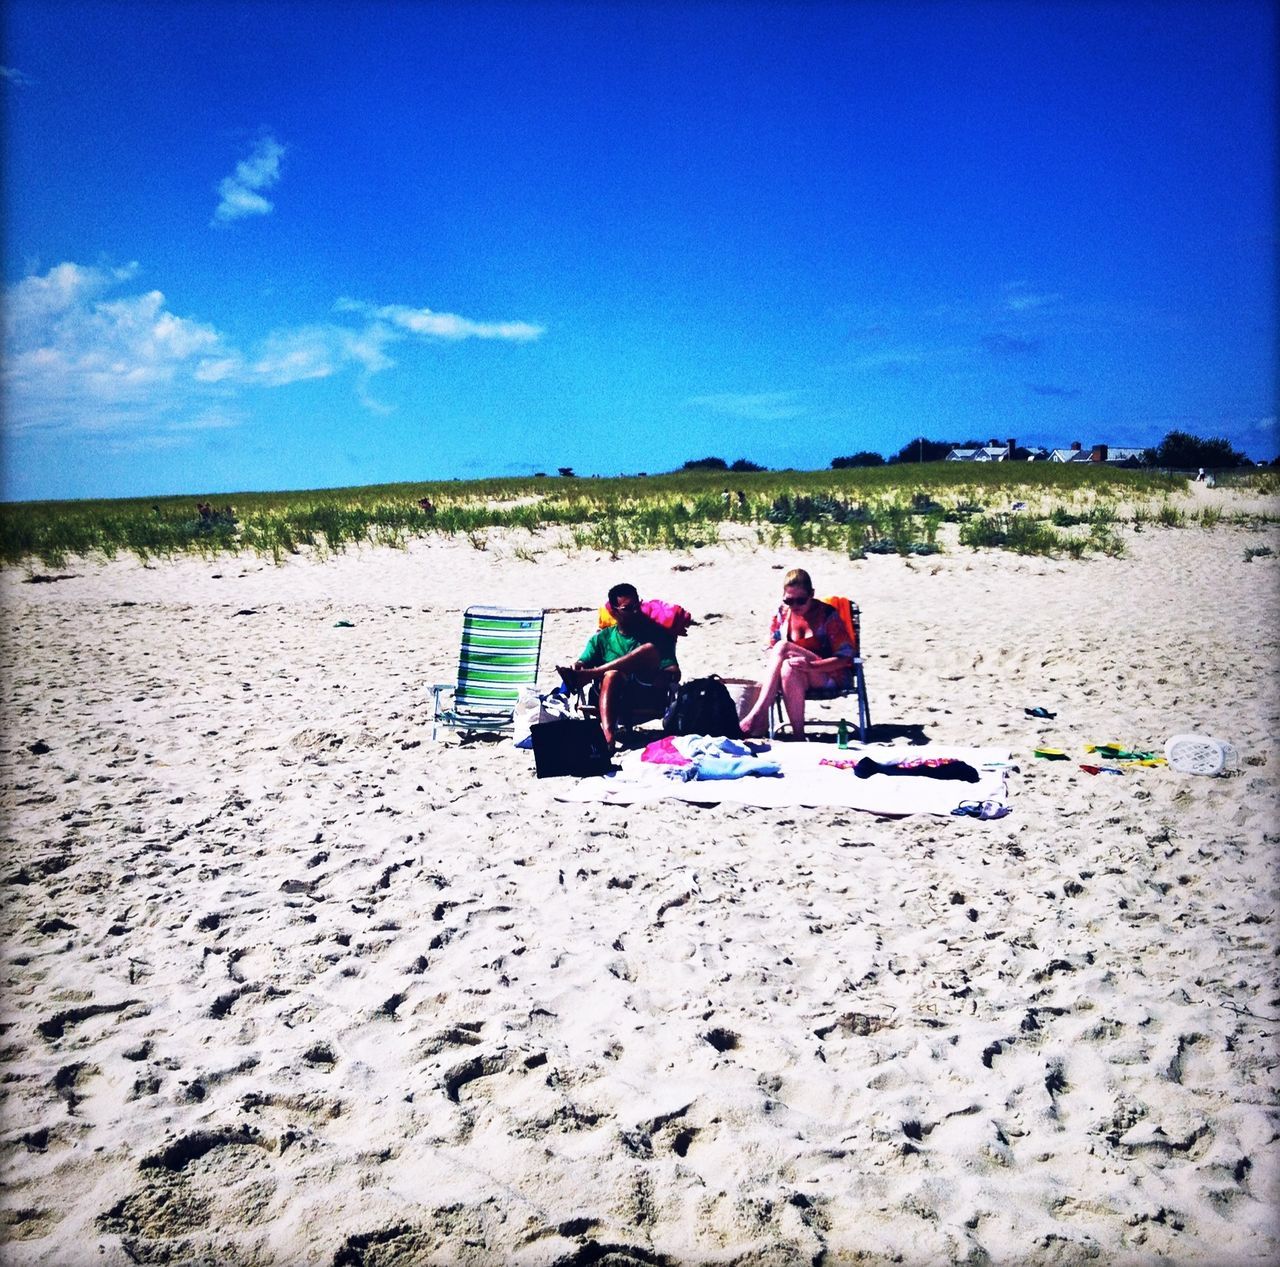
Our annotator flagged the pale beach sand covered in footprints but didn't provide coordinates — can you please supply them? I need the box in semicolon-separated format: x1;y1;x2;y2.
0;526;1280;1267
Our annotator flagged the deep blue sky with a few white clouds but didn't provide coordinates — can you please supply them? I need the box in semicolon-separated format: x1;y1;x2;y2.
0;0;1277;499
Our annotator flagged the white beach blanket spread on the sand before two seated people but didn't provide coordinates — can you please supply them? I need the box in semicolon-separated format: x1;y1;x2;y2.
556;744;1010;815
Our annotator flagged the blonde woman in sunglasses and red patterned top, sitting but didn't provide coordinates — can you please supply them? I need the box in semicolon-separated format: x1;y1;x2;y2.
742;568;856;738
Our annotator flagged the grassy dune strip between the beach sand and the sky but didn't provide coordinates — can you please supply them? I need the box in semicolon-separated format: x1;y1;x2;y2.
0;462;1276;567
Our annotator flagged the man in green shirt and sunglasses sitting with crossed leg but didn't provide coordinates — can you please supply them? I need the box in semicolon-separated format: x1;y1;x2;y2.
556;582;680;747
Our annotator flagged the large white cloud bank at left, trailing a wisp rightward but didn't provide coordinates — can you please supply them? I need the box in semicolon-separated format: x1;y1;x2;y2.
3;262;544;443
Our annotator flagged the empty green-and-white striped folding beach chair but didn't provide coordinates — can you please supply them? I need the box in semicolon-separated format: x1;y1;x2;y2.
431;607;543;740
